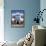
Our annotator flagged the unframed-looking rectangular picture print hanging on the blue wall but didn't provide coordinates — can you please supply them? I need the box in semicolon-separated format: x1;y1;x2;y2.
11;10;25;27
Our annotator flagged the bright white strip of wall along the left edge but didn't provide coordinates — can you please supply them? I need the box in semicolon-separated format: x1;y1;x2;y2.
0;0;4;42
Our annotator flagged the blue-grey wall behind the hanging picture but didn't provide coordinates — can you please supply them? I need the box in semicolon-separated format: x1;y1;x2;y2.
4;0;40;41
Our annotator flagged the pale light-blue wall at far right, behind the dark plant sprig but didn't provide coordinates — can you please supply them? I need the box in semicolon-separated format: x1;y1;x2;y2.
40;0;46;43
